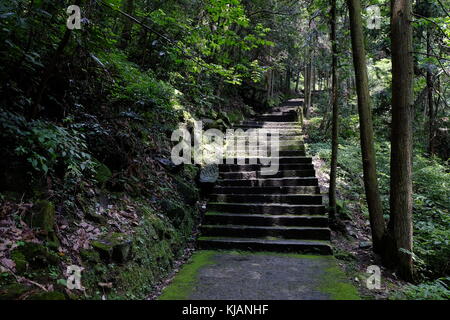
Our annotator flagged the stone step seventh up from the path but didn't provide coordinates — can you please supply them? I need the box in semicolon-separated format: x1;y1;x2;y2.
218;177;319;187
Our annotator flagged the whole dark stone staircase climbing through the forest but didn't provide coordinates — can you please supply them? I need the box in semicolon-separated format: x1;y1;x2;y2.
198;103;332;254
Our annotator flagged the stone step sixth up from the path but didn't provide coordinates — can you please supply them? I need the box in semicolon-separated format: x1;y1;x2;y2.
213;186;320;194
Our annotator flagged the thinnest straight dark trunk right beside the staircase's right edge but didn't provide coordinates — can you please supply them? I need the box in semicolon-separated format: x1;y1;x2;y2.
329;0;339;221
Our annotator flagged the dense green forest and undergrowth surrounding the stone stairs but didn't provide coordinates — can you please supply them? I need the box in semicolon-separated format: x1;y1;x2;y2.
0;0;450;299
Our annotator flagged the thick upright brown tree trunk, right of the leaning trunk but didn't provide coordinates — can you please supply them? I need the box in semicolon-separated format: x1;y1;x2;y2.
389;0;413;280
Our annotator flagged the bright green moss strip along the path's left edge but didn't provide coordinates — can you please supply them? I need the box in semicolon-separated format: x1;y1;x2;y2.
158;250;217;300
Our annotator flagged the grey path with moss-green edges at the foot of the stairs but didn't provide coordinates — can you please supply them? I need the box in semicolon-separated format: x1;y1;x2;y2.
159;251;359;300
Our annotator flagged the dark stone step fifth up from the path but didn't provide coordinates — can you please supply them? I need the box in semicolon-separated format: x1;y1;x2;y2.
210;194;322;204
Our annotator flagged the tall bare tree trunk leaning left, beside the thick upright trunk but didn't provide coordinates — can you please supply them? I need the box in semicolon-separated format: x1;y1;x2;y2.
347;0;386;252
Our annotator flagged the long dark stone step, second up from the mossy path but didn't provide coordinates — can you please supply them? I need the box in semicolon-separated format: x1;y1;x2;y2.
200;225;330;240
